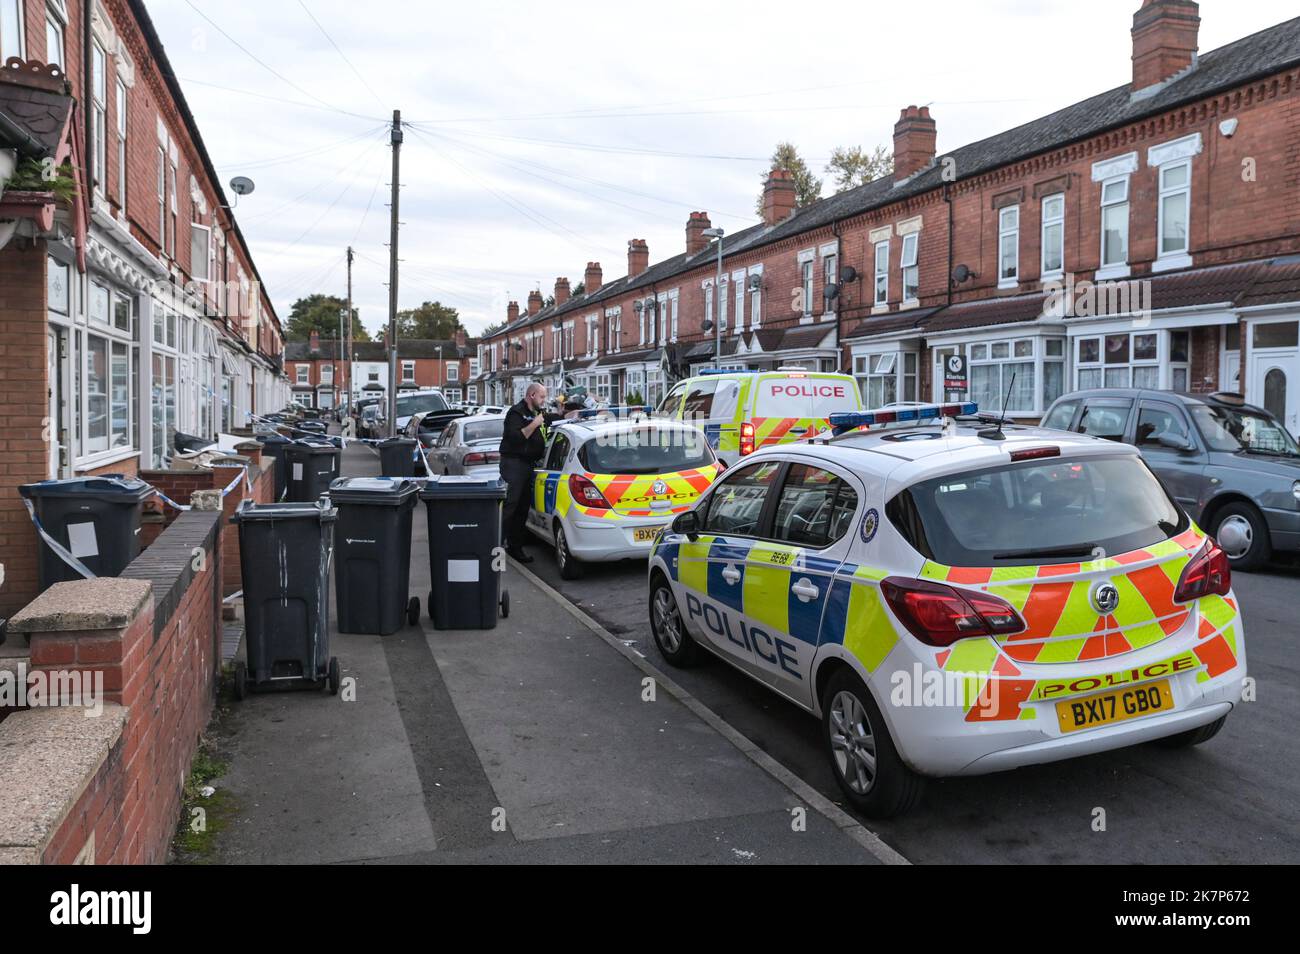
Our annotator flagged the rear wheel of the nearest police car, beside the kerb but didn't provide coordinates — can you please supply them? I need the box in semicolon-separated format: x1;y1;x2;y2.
822;668;926;819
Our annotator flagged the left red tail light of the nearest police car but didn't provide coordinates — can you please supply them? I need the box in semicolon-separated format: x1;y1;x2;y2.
880;576;1024;646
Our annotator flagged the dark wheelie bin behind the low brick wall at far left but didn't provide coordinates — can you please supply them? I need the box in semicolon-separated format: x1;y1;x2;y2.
18;473;153;590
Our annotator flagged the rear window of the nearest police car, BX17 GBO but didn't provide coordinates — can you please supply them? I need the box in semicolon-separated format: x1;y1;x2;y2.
885;456;1188;567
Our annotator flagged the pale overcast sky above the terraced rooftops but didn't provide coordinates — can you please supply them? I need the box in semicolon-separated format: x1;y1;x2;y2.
148;0;1296;333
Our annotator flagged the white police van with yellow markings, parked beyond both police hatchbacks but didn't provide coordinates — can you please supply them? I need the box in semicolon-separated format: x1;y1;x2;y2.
655;368;862;465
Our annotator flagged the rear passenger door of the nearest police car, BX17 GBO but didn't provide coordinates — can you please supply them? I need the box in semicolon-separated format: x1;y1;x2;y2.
745;461;859;707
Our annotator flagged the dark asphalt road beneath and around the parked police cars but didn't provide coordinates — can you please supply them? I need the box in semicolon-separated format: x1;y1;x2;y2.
529;541;1300;864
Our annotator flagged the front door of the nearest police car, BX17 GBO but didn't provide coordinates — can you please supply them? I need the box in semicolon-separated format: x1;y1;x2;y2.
672;460;785;676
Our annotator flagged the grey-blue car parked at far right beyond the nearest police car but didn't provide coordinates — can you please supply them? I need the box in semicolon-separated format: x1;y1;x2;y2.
1043;387;1300;569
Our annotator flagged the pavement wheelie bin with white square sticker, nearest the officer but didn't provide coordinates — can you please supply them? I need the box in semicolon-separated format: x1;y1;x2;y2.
420;476;510;629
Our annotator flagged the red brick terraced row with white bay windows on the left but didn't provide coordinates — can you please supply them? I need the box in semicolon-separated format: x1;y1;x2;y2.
0;0;289;615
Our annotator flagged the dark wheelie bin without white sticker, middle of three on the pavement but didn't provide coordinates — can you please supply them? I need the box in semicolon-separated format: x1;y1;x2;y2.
329;477;420;636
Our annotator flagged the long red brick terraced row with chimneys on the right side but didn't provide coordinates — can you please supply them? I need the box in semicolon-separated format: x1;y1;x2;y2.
478;0;1300;432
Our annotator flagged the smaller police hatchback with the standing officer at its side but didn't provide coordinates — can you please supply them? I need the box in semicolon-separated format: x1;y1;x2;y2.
528;407;724;580
